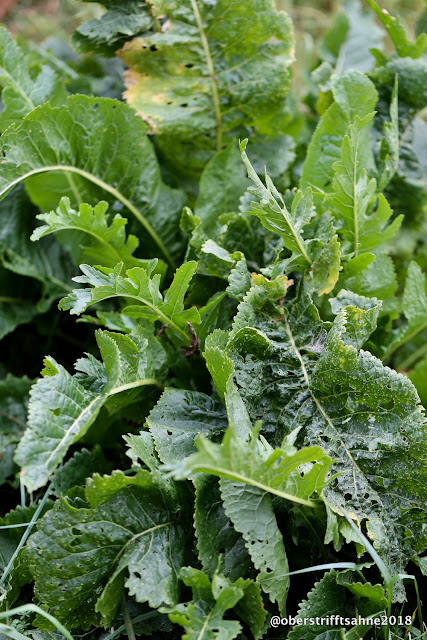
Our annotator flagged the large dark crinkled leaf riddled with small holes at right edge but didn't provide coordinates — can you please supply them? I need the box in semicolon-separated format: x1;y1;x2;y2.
226;286;427;584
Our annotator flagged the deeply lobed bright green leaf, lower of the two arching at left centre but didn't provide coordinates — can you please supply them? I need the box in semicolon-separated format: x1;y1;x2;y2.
59;260;200;344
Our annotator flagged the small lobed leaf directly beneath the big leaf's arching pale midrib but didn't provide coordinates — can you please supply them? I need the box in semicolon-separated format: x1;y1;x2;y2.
31;197;166;275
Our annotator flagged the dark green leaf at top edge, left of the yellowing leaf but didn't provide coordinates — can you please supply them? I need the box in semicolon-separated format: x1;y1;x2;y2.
73;0;153;56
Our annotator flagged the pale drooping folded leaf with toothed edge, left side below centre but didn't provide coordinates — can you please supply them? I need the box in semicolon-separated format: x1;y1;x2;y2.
15;331;164;491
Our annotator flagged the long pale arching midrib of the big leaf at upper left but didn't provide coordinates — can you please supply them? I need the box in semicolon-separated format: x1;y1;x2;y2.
0;164;175;268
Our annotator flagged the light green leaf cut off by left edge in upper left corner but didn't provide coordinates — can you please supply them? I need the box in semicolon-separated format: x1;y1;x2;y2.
0;26;65;131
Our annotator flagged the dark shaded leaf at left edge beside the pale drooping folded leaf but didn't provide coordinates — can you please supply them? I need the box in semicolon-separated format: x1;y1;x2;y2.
0;374;32;485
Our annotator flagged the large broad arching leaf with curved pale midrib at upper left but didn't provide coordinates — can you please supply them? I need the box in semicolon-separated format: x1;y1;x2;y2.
0;95;186;262
